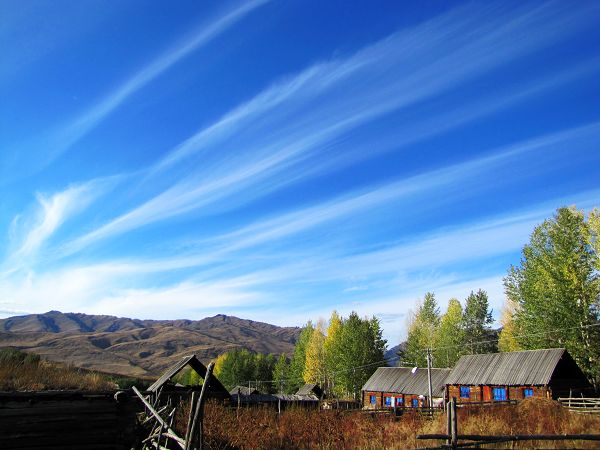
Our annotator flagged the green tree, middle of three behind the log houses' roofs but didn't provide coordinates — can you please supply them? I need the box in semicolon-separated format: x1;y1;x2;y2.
433;298;465;367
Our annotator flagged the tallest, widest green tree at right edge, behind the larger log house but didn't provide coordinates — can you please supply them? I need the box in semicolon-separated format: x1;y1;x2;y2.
504;207;600;388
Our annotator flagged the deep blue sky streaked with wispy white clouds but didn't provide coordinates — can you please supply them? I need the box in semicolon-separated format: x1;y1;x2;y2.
0;0;600;345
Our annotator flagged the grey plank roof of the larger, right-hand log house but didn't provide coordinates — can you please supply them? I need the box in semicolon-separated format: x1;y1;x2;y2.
446;348;568;386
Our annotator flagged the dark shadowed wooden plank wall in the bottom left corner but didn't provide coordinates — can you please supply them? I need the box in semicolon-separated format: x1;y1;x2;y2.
0;392;140;450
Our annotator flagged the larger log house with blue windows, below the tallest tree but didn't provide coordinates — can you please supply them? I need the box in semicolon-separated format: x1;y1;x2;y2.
446;348;592;403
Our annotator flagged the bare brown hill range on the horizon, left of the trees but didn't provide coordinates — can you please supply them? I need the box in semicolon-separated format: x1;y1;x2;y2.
0;311;300;377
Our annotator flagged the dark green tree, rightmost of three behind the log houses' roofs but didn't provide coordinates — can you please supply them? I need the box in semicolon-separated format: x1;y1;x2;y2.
463;289;497;353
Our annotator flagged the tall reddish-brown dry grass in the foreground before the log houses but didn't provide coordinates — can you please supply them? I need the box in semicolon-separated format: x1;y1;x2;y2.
177;399;600;450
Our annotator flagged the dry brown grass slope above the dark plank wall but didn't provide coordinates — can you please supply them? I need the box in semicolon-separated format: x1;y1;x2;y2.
0;349;115;391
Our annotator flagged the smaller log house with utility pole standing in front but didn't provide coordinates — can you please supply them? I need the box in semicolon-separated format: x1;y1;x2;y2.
362;367;450;409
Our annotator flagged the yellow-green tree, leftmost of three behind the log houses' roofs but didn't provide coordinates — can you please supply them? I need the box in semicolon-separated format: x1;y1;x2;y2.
398;292;440;367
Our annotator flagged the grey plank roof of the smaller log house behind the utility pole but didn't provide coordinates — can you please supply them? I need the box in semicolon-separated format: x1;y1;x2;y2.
363;367;450;397
